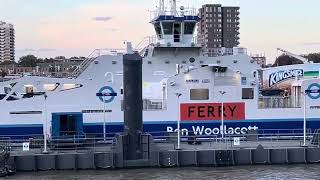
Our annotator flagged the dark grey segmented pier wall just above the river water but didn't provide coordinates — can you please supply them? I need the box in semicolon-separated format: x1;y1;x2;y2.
6;146;320;171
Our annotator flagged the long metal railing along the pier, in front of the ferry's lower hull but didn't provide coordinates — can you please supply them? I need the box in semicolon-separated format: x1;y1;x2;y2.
0;129;320;155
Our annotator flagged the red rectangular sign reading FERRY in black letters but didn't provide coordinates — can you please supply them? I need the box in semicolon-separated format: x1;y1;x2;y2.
180;103;245;121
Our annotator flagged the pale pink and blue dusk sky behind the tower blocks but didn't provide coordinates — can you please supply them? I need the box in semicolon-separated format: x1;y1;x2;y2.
0;0;320;62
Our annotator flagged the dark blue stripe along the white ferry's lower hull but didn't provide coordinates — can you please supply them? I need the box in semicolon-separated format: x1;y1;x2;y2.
0;119;320;137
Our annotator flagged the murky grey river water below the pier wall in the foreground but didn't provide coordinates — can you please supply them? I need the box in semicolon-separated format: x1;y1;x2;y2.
6;164;320;180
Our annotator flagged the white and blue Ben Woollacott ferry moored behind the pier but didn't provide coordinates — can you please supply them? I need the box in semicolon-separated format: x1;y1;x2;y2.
0;1;320;138
